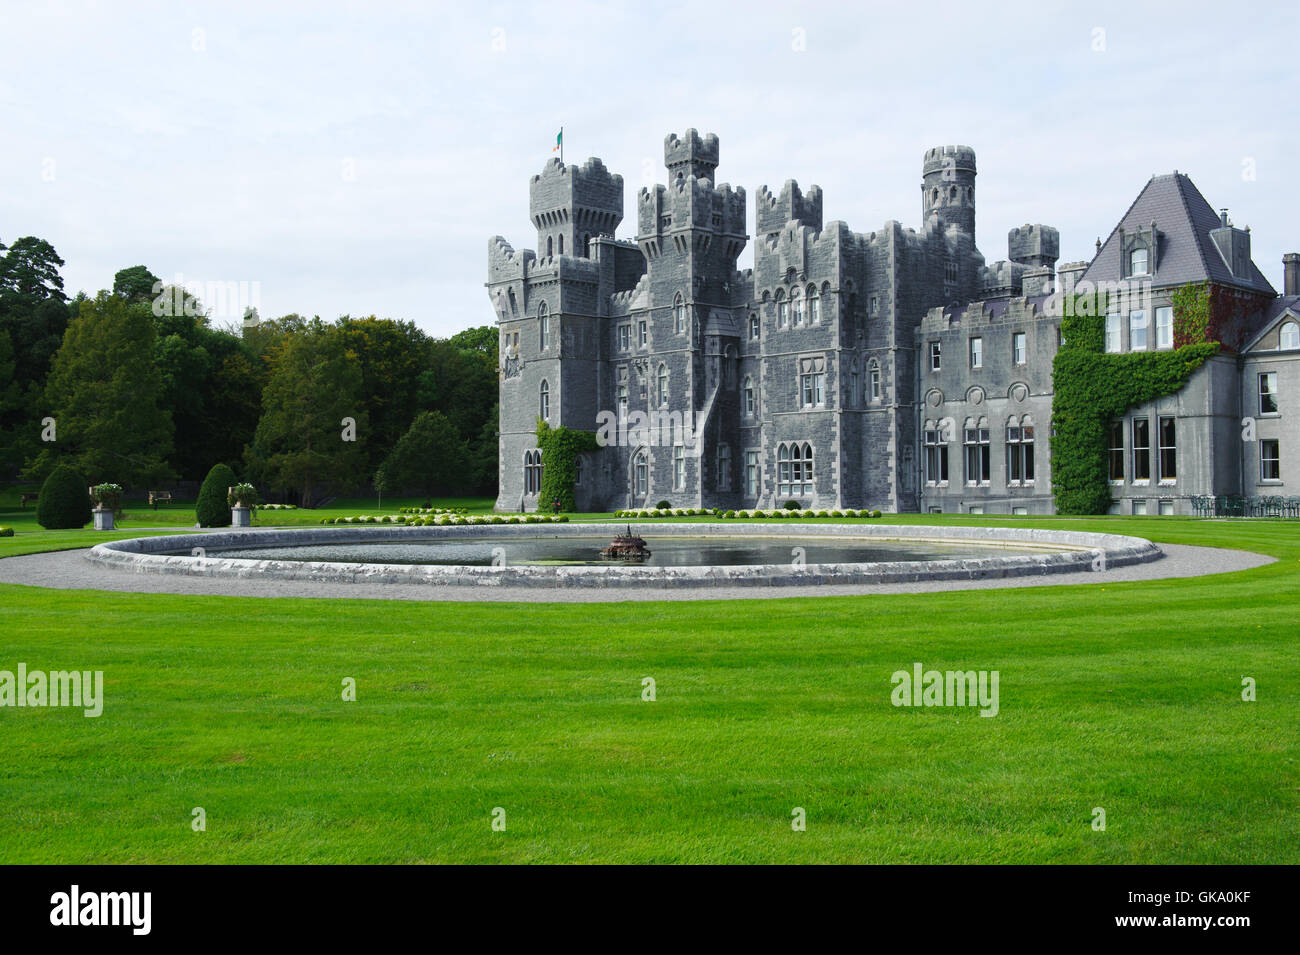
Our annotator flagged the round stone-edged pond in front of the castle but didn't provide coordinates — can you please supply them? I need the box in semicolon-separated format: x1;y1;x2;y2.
88;522;1162;587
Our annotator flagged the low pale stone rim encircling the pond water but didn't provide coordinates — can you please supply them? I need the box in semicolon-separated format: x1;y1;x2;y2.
86;522;1164;590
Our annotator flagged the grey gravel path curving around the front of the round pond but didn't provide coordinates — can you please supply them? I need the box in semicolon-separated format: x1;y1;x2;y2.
0;544;1275;603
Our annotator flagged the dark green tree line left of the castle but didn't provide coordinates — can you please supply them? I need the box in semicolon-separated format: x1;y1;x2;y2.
0;236;498;507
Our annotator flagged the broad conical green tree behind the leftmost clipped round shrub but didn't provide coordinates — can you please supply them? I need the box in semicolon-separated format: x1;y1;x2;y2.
27;292;172;485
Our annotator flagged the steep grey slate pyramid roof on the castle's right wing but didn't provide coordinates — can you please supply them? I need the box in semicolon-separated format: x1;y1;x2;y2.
1079;173;1277;295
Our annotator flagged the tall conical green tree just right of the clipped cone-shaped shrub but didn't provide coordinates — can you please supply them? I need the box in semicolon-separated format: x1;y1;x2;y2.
247;318;367;507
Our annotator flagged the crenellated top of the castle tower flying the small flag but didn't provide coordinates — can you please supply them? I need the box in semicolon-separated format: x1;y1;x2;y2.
528;157;623;259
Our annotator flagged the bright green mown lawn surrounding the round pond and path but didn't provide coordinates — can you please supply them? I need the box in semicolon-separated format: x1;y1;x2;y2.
0;505;1300;863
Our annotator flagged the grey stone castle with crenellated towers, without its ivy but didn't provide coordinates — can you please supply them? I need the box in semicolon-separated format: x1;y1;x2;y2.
488;130;1300;515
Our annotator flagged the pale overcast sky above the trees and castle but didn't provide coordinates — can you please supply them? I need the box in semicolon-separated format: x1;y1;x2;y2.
0;0;1300;335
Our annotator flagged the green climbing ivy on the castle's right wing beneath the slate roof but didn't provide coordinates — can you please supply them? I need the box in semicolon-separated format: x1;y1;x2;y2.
1052;295;1219;515
